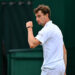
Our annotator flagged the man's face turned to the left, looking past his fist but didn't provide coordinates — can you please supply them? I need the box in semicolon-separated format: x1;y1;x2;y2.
35;10;48;26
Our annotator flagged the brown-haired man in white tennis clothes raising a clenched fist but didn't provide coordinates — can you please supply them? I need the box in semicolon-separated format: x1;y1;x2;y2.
26;5;67;75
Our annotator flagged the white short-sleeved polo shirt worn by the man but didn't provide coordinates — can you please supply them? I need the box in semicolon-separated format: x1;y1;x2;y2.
35;21;64;69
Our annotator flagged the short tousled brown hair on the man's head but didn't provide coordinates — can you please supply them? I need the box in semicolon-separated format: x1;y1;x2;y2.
34;4;51;18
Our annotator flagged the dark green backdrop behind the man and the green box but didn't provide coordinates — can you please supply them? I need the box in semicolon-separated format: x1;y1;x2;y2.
0;0;75;75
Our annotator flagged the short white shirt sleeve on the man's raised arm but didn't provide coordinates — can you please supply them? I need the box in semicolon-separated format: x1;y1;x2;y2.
35;30;51;44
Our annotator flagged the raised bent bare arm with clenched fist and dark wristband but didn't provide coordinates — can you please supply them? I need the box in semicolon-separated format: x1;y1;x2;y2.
26;21;40;48
